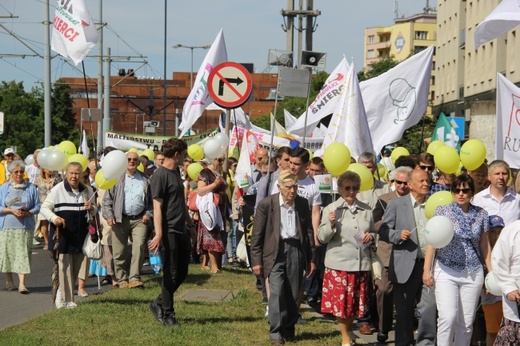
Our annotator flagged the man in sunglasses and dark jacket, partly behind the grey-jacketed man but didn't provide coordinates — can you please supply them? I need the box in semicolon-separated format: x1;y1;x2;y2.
373;166;412;342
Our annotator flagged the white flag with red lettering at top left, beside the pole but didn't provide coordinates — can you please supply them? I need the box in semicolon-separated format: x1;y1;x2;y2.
51;0;99;65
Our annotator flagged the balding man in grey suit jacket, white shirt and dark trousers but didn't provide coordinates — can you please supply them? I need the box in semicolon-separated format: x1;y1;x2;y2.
379;169;436;346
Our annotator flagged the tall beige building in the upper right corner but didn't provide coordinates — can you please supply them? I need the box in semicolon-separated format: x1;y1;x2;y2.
434;0;520;160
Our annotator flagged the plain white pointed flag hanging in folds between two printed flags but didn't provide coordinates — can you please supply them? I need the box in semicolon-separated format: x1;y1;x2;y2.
322;64;374;159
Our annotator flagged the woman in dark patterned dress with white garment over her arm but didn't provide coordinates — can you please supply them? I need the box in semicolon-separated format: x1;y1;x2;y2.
197;157;228;273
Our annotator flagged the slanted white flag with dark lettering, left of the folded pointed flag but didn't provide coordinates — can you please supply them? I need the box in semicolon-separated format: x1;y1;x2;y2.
287;58;349;136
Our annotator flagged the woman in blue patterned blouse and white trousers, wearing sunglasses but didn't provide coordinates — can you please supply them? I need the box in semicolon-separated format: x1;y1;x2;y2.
423;175;491;345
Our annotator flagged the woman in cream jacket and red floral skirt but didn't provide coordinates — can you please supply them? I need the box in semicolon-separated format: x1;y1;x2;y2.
318;171;375;346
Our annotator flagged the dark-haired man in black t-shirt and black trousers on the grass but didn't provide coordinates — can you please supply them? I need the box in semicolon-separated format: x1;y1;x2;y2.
148;138;195;327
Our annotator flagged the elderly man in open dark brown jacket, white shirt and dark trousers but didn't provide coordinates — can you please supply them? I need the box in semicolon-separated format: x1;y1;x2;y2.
251;171;315;345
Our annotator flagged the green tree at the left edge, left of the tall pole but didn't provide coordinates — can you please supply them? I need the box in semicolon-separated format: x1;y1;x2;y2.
0;81;43;157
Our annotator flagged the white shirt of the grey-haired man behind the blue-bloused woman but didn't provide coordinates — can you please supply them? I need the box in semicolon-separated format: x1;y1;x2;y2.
472;187;520;226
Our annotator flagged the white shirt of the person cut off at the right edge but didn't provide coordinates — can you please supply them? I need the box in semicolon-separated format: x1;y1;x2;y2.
491;221;520;323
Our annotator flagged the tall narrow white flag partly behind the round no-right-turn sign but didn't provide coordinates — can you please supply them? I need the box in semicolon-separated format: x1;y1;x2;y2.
179;29;227;137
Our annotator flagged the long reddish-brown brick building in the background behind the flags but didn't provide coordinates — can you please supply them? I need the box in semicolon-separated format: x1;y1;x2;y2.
63;70;278;136
